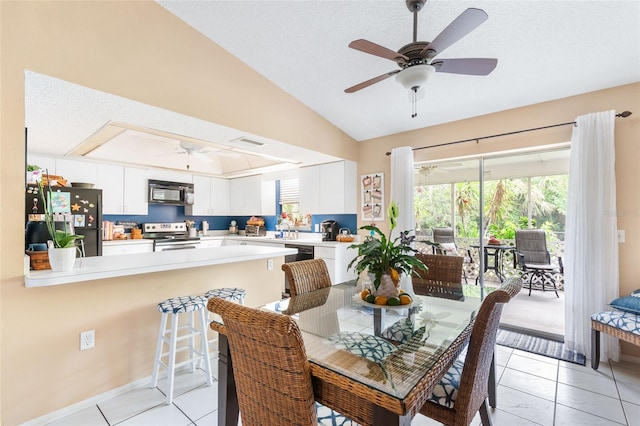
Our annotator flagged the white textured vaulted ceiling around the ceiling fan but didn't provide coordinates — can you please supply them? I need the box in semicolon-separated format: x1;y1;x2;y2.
158;0;640;140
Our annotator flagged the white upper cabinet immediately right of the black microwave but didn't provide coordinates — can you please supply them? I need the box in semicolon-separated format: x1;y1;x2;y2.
184;175;229;216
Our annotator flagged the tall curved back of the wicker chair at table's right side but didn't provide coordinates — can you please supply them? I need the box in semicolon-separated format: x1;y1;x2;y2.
454;277;522;424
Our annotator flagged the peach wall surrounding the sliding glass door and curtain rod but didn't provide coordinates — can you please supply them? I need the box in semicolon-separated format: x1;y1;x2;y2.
358;83;640;357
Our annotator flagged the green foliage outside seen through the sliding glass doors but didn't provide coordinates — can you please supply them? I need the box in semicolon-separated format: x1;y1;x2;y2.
414;175;569;239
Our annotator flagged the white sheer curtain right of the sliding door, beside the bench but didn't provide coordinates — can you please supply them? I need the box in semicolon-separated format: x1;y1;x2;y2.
564;111;620;361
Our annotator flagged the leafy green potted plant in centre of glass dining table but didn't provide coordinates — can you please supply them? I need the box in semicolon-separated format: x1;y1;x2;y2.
348;201;427;303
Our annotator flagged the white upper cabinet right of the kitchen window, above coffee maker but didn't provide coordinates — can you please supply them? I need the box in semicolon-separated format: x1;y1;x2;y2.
299;161;357;214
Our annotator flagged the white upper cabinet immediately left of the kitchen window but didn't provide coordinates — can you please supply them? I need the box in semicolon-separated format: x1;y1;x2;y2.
229;175;276;216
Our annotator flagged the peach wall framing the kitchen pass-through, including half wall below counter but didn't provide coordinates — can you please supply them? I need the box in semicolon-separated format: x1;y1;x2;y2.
0;1;358;425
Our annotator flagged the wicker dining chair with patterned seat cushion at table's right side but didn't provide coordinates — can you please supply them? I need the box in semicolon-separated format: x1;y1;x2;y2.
420;277;522;426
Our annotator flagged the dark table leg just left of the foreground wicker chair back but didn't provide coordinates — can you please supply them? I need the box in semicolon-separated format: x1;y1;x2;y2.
218;334;240;426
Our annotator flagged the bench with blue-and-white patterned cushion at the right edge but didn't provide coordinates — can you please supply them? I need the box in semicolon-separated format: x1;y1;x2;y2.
591;290;640;370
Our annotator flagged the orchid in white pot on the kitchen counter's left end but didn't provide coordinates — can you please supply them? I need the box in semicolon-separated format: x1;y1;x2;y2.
38;181;84;271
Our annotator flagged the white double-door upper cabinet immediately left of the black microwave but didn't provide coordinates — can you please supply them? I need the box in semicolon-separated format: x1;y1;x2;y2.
96;164;149;215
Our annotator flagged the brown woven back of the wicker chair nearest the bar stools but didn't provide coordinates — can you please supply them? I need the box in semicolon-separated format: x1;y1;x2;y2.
208;297;317;426
